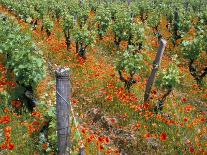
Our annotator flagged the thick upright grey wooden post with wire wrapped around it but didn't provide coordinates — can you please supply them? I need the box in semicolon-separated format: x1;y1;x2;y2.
56;68;71;155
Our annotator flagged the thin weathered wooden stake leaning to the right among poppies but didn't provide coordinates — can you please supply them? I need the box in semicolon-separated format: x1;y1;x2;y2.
144;39;167;102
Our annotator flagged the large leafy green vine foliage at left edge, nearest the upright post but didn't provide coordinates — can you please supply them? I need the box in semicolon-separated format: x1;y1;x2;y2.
0;18;45;87
